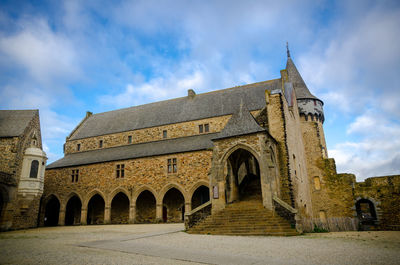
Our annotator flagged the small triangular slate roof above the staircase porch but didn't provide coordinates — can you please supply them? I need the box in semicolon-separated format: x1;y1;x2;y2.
213;104;265;140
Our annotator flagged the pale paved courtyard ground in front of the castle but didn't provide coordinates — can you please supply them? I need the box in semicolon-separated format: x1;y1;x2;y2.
0;224;400;264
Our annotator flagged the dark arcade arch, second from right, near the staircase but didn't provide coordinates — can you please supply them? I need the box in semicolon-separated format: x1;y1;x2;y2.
163;188;185;223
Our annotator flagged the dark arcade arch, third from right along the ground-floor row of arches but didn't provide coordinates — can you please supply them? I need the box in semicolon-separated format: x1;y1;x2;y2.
136;190;156;223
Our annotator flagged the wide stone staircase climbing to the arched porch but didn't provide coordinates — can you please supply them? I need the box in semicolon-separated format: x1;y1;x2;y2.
187;196;298;236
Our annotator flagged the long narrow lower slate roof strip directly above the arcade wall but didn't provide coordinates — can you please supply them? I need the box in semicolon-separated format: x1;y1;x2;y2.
46;133;216;169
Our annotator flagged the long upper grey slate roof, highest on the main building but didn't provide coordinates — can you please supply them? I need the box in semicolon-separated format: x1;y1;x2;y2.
70;79;281;140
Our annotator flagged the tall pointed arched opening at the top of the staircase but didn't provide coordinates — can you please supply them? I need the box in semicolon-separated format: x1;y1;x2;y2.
226;148;262;203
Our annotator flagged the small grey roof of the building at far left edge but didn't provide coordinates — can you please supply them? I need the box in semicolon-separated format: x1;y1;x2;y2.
0;110;39;137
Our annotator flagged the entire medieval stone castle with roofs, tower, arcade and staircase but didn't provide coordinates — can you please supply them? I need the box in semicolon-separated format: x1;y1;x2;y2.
0;52;400;232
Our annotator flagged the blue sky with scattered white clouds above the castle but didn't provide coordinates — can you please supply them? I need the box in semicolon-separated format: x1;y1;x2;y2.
0;0;400;180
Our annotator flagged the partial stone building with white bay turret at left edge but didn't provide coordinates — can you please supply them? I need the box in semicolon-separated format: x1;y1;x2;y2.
0;110;47;230
